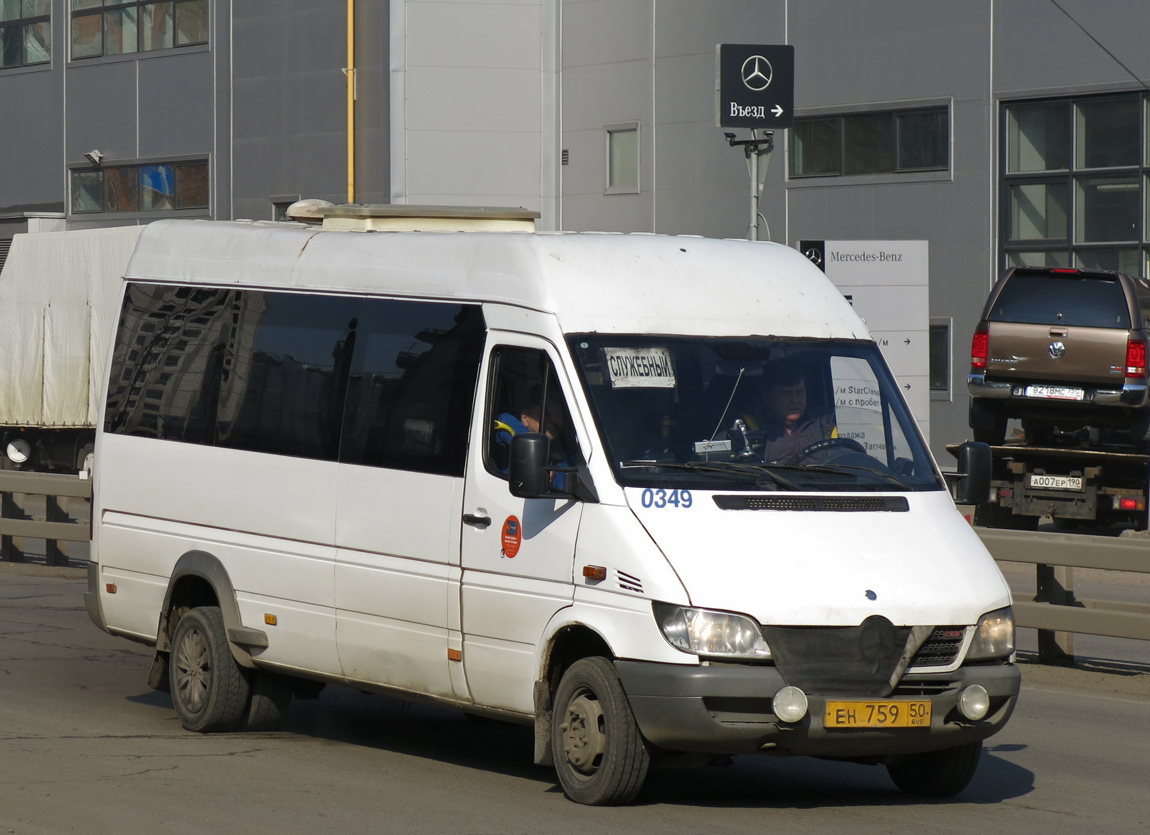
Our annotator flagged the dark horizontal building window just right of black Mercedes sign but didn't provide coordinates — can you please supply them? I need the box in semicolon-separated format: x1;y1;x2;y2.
790;107;950;177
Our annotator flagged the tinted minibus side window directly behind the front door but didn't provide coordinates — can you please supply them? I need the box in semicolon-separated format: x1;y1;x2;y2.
339;299;485;476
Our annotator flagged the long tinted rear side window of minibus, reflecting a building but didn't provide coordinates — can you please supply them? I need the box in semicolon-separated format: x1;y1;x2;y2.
105;284;359;460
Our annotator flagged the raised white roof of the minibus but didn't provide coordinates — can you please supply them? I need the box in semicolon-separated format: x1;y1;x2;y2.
128;221;869;338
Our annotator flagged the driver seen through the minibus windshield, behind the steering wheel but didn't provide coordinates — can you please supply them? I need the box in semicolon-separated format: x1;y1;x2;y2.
743;360;838;464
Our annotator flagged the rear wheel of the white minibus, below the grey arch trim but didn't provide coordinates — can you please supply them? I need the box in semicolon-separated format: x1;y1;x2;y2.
168;606;251;734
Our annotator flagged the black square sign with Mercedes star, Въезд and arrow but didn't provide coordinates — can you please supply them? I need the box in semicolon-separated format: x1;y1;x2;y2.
715;44;795;130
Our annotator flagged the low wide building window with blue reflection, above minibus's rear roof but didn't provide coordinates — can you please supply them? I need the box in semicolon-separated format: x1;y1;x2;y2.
71;162;208;214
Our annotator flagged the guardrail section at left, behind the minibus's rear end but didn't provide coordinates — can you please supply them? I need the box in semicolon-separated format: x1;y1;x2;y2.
0;470;92;566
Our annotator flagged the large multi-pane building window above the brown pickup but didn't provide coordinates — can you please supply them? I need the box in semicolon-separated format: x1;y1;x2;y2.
1001;94;1150;275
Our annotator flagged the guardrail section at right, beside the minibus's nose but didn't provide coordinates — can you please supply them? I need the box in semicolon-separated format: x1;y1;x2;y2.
975;528;1150;662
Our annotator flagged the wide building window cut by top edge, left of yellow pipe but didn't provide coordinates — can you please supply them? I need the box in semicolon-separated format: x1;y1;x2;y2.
70;0;208;61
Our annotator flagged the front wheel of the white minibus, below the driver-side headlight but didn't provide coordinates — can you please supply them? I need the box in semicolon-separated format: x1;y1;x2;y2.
551;657;651;806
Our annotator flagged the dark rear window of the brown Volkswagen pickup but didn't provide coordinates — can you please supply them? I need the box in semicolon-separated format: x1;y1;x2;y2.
989;274;1130;328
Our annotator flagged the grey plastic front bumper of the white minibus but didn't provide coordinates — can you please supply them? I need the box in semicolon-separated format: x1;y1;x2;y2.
615;661;1021;758
